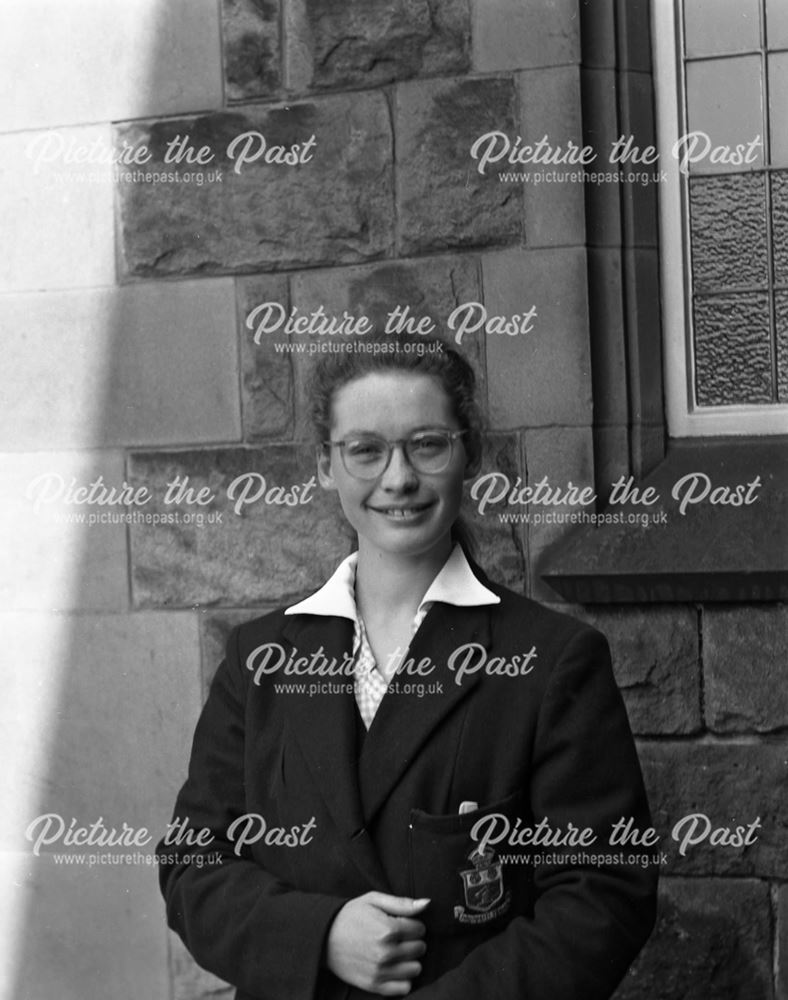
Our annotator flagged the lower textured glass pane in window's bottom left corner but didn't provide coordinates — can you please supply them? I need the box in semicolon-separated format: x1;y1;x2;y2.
695;294;772;406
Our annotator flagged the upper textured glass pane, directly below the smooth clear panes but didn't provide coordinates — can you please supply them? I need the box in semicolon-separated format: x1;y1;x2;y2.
690;174;768;292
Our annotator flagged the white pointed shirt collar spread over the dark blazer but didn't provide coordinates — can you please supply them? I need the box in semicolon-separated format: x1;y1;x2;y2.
285;545;501;622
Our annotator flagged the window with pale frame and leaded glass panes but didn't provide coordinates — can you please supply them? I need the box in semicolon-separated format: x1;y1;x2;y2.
652;0;788;437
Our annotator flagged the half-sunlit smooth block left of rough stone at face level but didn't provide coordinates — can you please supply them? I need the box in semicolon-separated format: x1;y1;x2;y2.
0;452;129;611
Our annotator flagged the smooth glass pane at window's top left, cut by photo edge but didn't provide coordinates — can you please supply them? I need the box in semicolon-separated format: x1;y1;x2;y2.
684;0;760;56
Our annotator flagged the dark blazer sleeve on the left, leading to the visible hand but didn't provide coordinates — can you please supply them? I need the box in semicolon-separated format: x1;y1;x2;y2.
158;630;346;1000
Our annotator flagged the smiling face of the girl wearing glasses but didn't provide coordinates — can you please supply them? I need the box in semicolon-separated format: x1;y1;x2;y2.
318;372;467;556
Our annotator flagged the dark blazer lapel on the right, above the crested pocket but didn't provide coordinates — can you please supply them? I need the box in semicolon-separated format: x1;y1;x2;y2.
358;604;490;823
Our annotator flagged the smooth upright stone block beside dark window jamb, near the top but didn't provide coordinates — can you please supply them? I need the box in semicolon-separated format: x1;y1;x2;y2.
515;66;585;247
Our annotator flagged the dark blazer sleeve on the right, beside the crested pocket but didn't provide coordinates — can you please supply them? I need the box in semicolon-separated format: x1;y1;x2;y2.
412;628;657;1000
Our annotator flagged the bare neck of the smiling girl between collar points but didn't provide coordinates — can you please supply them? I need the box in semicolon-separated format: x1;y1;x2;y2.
356;535;453;621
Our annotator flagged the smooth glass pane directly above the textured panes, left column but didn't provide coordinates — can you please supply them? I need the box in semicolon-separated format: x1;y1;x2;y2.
687;56;763;173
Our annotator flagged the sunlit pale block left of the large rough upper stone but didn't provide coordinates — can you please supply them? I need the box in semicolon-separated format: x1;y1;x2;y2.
0;123;115;292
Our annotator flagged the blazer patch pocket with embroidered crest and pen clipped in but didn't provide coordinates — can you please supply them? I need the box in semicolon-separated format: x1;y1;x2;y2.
410;792;533;934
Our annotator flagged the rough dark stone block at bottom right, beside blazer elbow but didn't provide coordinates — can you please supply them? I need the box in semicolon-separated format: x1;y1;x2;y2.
615;878;774;1000
